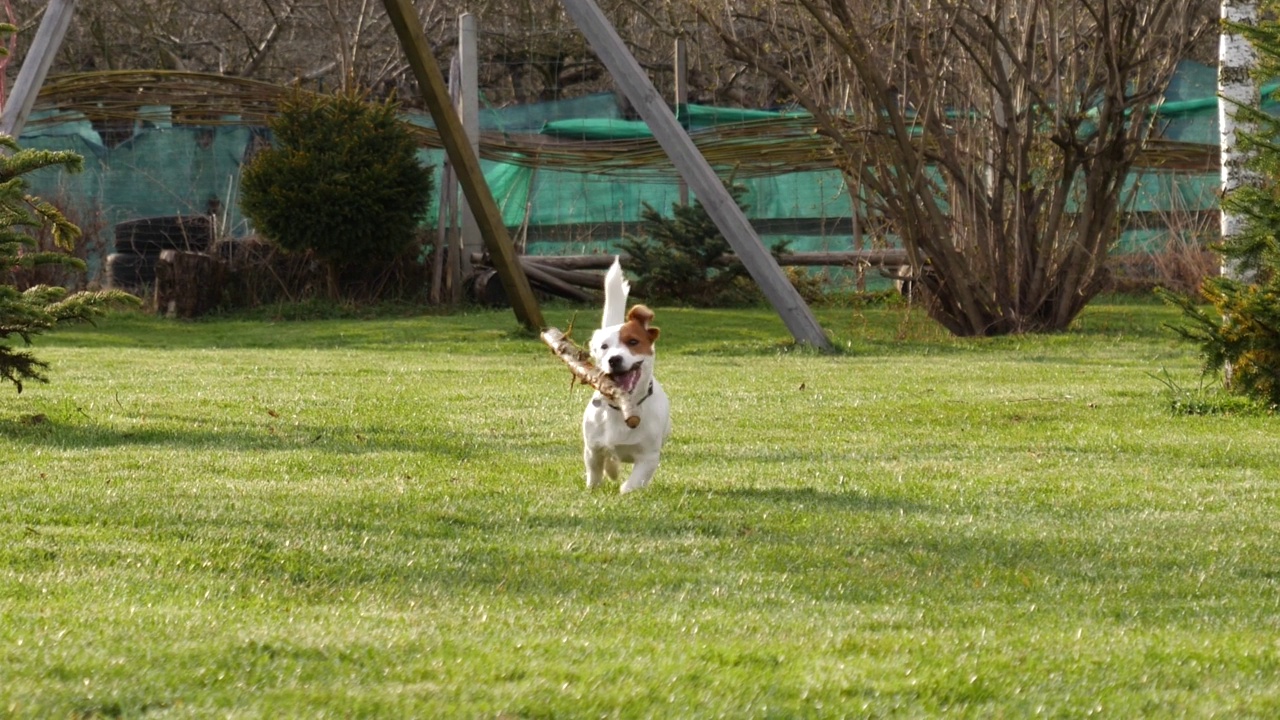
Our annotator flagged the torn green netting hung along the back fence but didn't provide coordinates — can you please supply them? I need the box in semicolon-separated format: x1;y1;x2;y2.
20;63;1233;283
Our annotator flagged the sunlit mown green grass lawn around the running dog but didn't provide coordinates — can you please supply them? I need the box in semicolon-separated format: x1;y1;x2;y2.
0;297;1280;717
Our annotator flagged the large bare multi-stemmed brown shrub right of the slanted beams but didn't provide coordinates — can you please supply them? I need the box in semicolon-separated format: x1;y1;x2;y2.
700;0;1212;336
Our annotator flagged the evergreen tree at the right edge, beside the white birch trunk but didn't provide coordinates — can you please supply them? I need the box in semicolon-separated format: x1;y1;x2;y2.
1162;0;1280;407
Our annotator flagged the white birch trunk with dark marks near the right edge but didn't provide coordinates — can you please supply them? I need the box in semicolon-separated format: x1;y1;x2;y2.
1217;0;1261;277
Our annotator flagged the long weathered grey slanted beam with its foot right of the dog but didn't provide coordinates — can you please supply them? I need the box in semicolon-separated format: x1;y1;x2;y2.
560;0;832;351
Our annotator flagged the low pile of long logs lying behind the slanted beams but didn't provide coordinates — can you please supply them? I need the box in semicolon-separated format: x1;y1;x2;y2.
471;250;906;305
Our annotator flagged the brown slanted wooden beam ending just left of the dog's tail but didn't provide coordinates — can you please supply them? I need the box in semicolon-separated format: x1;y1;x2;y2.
383;0;545;332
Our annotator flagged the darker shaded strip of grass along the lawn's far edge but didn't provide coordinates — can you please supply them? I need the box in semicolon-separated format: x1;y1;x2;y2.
40;299;1176;356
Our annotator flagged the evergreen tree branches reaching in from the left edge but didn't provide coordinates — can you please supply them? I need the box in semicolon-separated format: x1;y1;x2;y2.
0;135;140;392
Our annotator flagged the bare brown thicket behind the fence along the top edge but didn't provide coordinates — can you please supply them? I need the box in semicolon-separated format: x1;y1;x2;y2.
2;0;1217;108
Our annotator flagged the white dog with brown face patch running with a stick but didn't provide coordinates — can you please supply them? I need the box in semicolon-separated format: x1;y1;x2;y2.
582;259;671;492
